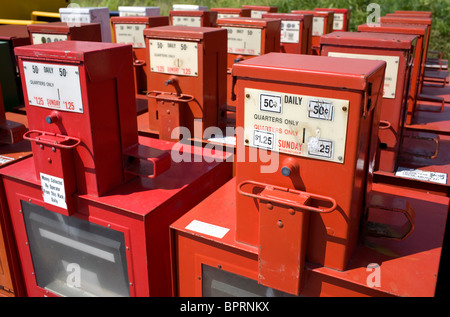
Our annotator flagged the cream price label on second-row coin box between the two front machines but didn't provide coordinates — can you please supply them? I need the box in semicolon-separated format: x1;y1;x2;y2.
149;40;198;76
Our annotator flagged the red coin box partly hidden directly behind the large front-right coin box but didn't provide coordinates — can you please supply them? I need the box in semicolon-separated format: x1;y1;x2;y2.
321;32;420;172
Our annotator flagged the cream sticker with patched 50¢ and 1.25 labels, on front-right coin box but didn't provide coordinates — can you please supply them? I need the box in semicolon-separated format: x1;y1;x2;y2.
244;88;349;163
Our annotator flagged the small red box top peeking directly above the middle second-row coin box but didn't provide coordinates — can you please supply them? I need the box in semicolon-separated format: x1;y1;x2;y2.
169;10;217;27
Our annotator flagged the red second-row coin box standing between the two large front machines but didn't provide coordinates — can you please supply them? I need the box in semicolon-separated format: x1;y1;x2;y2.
144;26;226;140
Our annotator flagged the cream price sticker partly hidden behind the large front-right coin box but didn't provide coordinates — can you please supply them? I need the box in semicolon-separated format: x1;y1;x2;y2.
328;52;400;99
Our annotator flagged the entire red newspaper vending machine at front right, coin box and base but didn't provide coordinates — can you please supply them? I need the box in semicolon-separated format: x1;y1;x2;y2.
171;53;449;297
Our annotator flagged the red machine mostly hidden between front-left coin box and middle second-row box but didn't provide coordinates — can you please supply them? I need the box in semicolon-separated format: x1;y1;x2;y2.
111;16;169;115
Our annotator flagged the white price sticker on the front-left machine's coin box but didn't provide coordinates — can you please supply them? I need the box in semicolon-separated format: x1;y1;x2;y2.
23;62;83;113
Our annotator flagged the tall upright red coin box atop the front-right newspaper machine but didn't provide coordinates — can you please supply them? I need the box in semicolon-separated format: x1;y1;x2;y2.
233;53;385;278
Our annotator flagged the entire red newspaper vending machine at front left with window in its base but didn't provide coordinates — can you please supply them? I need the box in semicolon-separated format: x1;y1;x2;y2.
0;41;231;297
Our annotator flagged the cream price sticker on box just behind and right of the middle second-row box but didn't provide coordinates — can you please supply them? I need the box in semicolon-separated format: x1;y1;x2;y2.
223;26;261;55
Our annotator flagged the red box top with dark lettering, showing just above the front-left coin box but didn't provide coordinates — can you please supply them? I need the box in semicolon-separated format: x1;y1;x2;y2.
28;22;102;44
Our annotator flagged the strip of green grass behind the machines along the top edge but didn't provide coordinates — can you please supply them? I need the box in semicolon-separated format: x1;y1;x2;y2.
72;0;450;59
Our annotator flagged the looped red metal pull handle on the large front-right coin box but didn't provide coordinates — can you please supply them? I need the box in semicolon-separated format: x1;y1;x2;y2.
237;181;337;213
